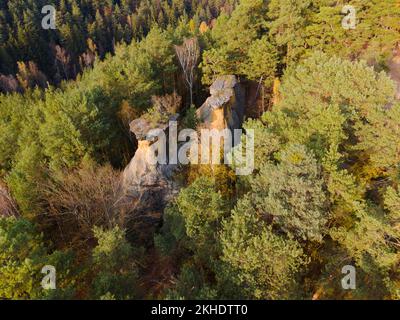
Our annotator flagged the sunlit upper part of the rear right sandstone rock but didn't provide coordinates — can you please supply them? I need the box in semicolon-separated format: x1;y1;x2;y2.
197;75;245;130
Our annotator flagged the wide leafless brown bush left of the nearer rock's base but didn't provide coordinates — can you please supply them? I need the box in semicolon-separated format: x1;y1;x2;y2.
42;165;132;241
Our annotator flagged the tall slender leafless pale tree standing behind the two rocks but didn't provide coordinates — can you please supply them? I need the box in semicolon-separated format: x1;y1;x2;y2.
175;38;200;105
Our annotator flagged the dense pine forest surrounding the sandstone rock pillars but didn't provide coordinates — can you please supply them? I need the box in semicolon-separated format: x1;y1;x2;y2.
0;0;400;300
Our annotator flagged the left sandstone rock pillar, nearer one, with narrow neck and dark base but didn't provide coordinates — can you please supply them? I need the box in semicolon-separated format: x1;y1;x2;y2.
122;115;178;243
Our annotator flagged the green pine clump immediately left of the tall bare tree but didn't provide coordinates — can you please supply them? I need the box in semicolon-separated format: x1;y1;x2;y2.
99;28;176;110
